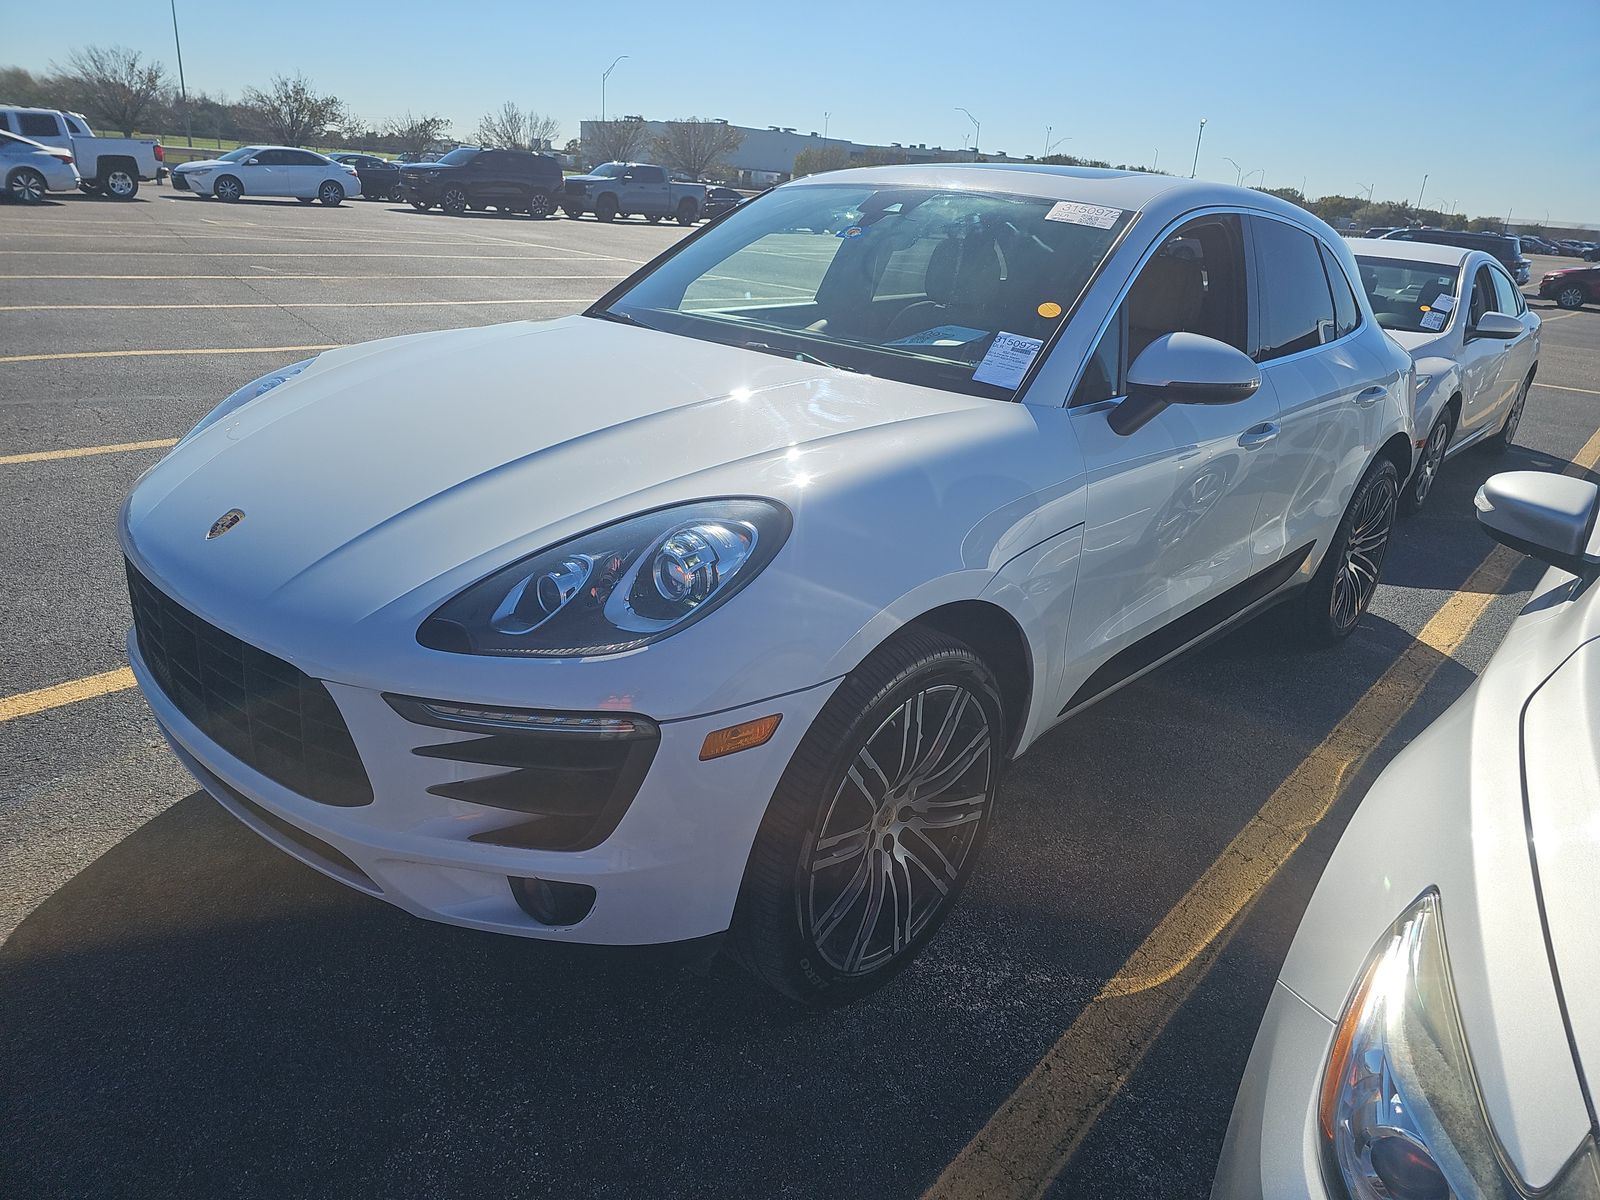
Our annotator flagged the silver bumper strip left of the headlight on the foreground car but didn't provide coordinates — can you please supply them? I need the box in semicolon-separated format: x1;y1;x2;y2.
1211;982;1334;1200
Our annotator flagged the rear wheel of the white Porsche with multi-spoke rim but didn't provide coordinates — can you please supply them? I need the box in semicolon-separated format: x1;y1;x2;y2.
1299;458;1400;646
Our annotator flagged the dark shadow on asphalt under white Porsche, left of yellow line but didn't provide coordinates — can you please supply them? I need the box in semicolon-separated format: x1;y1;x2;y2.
0;618;1491;1200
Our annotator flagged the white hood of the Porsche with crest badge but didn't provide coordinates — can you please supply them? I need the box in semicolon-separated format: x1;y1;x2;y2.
123;317;994;640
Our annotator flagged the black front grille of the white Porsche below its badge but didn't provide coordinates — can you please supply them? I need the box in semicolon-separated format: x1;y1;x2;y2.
128;563;373;808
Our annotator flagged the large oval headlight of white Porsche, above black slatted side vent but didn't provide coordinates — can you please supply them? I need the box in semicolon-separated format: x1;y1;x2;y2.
416;498;792;658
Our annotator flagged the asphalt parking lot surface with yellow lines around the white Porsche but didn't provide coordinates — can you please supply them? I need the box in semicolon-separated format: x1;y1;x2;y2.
9;187;1600;1198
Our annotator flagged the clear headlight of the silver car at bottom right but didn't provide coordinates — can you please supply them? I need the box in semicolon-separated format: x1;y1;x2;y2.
1318;891;1600;1200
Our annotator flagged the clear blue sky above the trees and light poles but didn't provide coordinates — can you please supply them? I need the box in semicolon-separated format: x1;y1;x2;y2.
0;0;1600;222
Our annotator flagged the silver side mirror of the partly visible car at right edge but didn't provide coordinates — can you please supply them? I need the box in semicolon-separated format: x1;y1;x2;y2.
1472;470;1600;574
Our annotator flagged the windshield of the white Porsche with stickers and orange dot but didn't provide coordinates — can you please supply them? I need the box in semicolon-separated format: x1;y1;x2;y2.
590;184;1133;400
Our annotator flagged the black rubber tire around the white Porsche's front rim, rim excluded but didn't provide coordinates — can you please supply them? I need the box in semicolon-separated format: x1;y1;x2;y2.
733;630;1006;1005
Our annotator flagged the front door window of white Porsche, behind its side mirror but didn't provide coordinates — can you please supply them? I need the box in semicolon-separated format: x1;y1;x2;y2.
1070;213;1248;406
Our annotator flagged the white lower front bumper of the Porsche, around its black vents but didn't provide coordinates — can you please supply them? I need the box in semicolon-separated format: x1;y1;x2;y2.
128;634;837;946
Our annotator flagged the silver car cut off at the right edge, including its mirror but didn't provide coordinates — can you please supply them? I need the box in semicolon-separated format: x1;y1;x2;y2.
1213;472;1600;1200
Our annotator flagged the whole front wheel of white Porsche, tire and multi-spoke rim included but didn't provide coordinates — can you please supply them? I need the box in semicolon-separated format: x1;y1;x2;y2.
730;629;1005;1005
